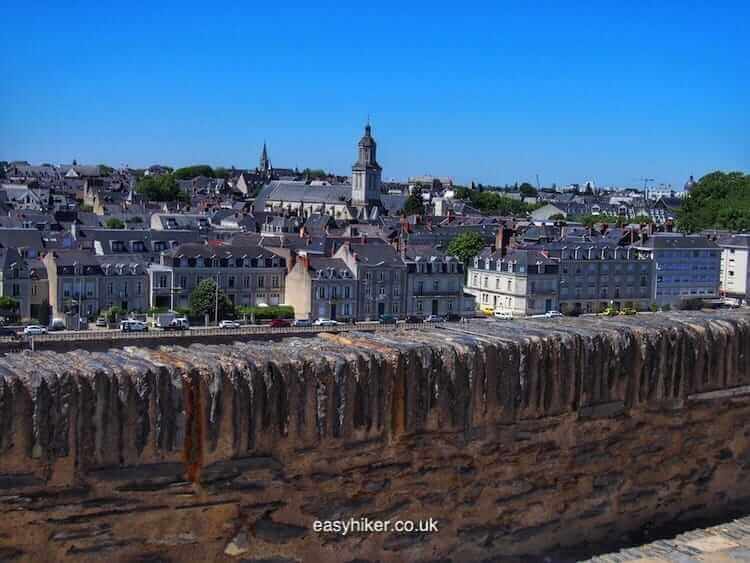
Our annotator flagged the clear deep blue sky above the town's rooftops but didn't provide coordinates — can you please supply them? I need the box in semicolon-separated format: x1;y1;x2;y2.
0;0;750;186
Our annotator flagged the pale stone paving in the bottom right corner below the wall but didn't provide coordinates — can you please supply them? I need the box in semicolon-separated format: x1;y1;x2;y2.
588;516;750;563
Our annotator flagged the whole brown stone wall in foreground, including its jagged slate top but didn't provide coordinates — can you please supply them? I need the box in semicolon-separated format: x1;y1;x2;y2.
0;312;750;562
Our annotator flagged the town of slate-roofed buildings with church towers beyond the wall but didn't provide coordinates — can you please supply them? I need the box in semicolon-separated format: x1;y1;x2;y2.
0;124;750;328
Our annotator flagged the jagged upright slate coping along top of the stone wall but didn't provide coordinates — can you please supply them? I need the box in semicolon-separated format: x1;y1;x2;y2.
0;311;750;482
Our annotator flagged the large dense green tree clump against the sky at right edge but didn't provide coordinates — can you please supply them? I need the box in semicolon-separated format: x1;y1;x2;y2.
677;172;750;232
